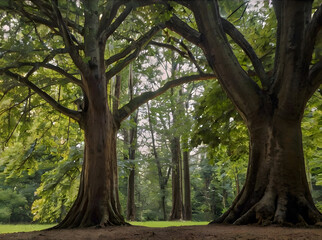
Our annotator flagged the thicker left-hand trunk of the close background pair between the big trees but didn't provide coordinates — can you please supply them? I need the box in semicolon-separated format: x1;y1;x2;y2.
169;137;182;220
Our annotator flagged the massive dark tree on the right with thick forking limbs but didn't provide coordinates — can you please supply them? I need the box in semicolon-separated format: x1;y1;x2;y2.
167;0;322;225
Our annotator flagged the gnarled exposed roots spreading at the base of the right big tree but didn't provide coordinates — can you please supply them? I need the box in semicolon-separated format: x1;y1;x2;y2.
212;188;322;227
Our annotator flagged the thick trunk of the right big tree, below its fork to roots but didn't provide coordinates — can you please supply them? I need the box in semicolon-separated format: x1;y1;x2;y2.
214;111;321;225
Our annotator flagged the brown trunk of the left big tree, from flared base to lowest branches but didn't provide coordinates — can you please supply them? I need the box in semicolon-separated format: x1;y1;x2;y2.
57;103;126;228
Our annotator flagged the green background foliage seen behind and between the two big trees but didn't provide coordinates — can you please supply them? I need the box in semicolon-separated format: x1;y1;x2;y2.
0;1;322;225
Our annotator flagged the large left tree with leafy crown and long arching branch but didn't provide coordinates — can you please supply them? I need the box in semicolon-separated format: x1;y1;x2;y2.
0;0;213;228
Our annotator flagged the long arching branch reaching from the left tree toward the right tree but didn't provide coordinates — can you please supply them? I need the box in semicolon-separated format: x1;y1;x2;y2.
115;74;216;122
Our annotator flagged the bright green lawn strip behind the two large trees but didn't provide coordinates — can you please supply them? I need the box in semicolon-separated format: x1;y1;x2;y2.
0;221;208;233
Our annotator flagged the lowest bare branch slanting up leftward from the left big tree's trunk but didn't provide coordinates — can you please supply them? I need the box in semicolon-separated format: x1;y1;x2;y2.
4;70;81;122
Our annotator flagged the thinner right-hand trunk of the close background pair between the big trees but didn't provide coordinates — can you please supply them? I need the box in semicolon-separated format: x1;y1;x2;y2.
182;142;192;220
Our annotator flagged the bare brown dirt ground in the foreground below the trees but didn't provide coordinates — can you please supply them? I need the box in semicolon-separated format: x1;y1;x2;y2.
0;224;322;240
